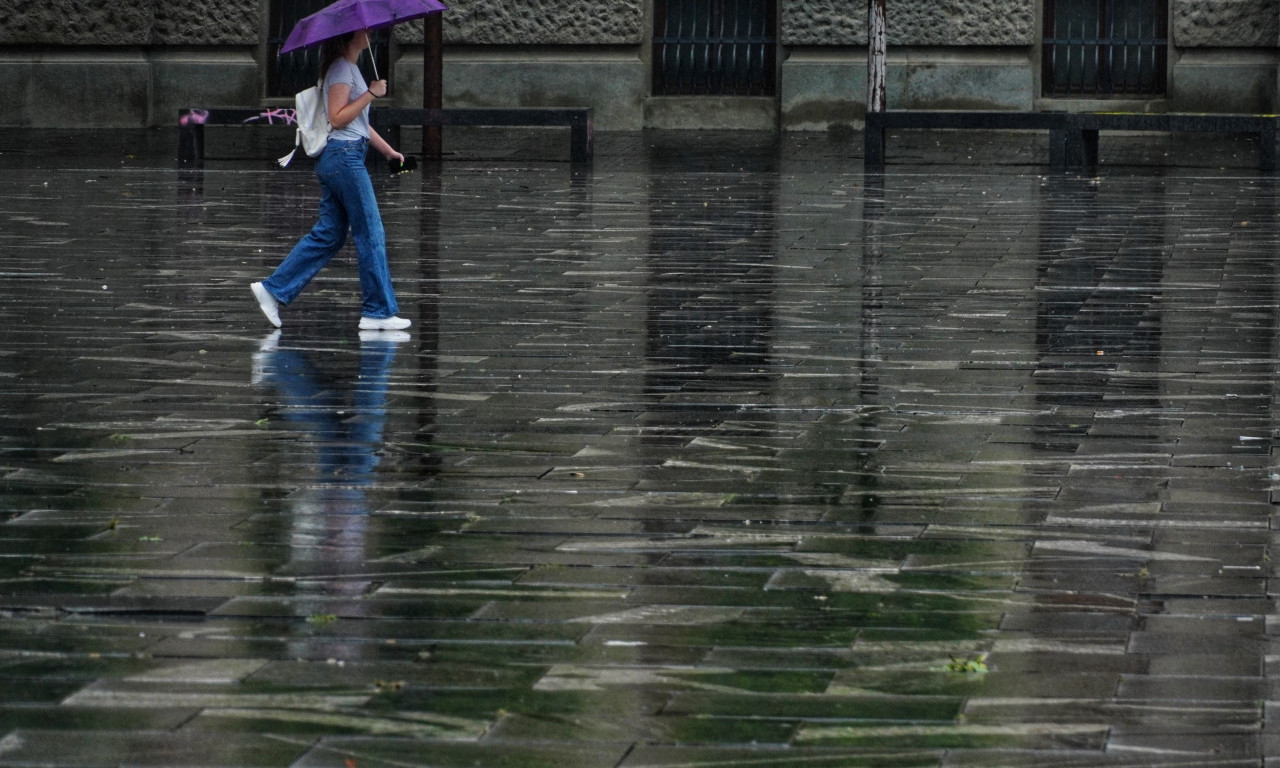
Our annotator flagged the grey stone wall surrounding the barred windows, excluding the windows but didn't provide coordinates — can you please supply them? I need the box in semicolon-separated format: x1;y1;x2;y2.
0;0;1280;131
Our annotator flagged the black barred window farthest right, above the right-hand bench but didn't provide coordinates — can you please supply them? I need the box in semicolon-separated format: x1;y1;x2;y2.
1042;0;1169;97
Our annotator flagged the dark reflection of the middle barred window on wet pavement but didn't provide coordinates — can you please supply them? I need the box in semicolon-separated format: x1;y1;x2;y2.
639;137;778;532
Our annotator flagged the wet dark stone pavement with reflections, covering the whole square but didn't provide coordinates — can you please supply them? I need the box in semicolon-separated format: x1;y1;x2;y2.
0;129;1280;768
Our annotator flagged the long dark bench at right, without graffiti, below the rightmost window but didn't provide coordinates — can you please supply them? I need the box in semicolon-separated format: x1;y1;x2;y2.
864;110;1280;170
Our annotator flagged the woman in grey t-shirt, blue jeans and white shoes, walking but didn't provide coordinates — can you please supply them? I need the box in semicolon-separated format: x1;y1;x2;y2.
250;29;411;330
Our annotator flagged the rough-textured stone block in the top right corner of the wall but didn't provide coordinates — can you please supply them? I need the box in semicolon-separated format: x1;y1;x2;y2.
1171;0;1280;47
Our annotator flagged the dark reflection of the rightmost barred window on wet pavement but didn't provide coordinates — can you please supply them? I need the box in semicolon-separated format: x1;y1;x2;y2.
1019;175;1176;632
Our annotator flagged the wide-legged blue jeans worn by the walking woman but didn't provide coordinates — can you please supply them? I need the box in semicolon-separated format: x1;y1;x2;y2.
262;141;399;319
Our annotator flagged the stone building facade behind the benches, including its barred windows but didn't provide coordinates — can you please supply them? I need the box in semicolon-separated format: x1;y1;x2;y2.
0;0;1280;131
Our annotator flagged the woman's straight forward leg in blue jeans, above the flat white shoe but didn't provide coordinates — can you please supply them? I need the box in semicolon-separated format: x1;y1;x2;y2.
334;143;399;319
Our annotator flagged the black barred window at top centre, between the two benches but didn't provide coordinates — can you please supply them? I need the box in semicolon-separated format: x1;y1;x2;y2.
653;0;777;96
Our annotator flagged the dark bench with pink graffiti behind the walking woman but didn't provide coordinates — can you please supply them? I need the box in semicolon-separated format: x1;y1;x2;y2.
178;106;594;168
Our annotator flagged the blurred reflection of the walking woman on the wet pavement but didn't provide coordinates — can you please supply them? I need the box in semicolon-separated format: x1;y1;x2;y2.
253;332;410;594
